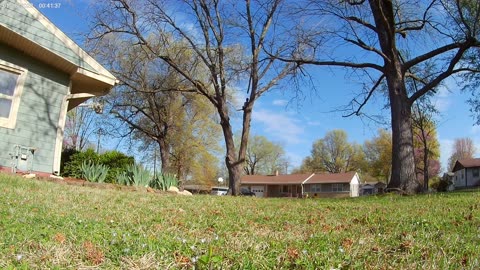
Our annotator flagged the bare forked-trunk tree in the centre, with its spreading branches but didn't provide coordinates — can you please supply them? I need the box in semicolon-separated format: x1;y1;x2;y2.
88;0;292;195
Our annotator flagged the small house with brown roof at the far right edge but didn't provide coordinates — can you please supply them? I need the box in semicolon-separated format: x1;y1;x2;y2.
452;158;480;189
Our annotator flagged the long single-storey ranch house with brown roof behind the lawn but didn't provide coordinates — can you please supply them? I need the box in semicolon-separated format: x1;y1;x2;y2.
240;172;360;198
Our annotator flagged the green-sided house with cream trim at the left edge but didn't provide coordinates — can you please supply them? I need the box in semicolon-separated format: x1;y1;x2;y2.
0;0;116;175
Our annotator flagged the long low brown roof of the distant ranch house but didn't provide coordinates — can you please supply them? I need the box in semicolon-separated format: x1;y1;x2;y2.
240;172;356;185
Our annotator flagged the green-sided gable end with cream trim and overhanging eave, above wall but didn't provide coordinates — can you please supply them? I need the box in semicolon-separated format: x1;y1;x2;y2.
0;0;117;109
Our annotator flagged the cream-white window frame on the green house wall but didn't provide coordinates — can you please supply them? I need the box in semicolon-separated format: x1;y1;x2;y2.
0;60;28;129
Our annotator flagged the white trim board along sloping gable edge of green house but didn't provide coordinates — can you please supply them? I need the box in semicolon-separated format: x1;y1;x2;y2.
17;0;116;82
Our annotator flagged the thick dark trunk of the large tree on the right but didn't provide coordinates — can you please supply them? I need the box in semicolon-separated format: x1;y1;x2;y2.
369;0;419;194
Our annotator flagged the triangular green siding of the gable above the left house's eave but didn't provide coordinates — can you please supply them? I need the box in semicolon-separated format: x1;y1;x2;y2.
0;0;95;71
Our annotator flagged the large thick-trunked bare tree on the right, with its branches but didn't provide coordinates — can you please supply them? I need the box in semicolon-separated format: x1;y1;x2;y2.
283;0;480;193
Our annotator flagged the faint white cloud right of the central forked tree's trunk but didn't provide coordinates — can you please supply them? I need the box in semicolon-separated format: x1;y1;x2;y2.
253;109;304;144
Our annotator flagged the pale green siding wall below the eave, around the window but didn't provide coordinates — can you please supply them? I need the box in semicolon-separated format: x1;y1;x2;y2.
0;44;69;173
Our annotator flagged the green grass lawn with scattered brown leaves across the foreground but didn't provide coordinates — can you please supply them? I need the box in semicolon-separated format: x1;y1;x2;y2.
0;175;480;269
